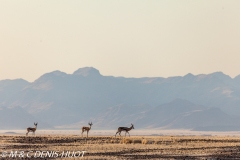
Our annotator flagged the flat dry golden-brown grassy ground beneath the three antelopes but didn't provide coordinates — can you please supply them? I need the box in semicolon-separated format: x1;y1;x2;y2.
0;135;240;159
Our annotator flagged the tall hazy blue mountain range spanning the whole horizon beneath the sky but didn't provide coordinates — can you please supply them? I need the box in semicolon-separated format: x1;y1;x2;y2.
0;67;240;130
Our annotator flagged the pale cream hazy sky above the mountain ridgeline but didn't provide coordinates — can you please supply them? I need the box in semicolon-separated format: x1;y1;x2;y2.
0;0;240;81
